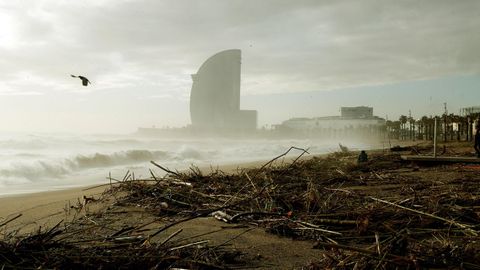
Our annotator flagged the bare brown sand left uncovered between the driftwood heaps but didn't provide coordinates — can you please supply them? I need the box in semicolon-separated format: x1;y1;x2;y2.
0;156;326;268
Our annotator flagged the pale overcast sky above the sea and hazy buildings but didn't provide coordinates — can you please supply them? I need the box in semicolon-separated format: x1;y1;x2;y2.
0;0;480;133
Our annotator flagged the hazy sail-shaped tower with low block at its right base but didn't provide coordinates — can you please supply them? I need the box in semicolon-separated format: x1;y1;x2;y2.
190;49;257;131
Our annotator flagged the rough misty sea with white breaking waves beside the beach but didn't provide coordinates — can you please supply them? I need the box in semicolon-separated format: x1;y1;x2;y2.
0;133;371;197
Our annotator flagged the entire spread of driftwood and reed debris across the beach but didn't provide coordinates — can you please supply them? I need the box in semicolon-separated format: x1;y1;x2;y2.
0;147;480;269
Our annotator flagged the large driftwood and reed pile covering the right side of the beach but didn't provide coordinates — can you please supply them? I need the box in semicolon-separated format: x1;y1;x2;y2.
110;148;480;269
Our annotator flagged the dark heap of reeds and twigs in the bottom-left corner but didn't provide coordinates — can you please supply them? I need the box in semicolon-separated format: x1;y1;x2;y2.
0;209;253;269
